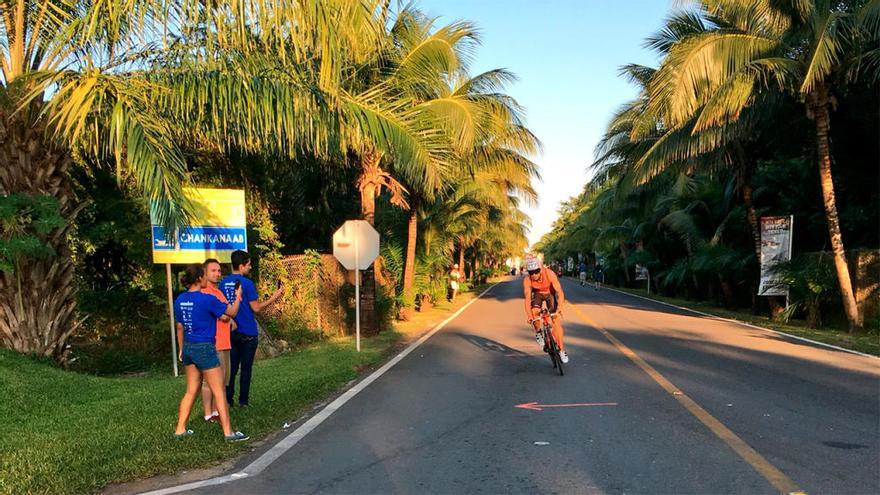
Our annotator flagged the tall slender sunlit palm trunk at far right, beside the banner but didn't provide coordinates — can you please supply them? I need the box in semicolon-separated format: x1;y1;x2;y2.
807;82;863;331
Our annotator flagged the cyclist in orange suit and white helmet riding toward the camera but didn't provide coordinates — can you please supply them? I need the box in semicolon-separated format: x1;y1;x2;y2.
523;255;568;364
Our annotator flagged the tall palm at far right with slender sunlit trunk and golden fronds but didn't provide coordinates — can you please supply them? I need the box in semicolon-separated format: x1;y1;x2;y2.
649;0;880;329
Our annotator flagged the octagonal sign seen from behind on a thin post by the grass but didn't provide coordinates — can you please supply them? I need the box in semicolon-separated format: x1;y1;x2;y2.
333;220;379;352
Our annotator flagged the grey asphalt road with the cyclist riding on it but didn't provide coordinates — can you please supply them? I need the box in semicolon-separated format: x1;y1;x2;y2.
182;280;880;494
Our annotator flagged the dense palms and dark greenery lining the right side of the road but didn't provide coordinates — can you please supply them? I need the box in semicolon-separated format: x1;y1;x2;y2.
537;0;880;344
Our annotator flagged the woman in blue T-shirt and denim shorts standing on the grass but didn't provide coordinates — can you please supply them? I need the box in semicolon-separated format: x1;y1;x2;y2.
174;264;249;442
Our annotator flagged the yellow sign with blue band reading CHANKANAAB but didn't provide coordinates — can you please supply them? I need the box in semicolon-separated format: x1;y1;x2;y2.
150;188;247;263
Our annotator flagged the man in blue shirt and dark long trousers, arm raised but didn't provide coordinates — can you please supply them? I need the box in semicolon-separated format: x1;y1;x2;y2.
220;250;284;407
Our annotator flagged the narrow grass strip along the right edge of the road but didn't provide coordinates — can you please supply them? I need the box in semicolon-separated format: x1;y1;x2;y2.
613;287;880;356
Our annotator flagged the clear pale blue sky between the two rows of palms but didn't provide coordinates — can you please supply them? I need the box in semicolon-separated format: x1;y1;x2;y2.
418;0;672;243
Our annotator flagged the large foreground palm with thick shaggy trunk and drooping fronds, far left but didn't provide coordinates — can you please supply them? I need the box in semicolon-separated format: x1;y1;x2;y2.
0;0;454;361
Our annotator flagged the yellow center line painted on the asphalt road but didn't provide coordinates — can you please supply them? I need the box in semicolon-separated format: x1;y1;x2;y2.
569;302;805;495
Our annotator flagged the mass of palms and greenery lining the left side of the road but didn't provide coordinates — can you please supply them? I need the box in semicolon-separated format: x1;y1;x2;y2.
0;0;539;374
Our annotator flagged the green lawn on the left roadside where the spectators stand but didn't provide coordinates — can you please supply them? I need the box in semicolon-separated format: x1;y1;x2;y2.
0;286;488;494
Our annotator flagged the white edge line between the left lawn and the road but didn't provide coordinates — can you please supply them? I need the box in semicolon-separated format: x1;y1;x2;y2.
140;282;501;495
